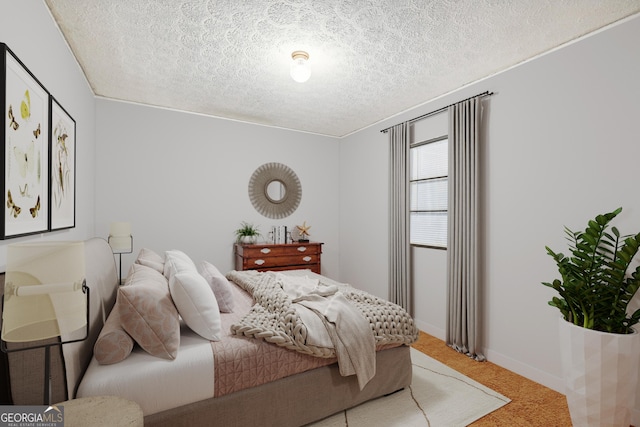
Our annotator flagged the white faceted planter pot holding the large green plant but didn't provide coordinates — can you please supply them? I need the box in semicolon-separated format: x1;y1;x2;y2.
559;318;640;427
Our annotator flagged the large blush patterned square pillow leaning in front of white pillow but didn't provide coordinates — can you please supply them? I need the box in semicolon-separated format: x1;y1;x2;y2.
116;283;180;360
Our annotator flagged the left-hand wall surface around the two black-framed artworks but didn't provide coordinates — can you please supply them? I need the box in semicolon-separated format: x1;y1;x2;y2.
0;1;95;271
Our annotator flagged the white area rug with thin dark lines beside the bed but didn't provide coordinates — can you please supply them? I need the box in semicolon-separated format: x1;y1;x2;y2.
310;348;511;427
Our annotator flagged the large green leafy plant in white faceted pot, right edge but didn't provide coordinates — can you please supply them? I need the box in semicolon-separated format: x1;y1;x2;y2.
543;208;640;427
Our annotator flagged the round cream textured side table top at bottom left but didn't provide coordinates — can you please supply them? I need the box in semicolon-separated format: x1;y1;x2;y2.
56;396;144;427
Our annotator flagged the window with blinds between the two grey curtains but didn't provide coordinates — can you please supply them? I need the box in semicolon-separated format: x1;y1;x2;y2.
409;136;449;249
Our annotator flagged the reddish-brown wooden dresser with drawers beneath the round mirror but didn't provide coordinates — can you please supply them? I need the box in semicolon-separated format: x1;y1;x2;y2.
235;242;322;274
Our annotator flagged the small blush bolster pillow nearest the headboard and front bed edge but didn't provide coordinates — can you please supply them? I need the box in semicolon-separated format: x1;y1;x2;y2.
93;305;133;365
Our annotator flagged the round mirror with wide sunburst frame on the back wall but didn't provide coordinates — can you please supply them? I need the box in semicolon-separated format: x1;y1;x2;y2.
249;163;302;219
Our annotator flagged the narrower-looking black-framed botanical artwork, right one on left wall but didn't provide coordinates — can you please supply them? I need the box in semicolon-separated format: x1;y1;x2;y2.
49;96;76;231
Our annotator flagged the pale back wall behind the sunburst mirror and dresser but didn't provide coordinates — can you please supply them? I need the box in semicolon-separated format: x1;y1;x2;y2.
96;99;340;277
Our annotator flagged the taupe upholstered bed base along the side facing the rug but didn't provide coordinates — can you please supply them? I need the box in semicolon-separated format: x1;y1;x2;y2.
144;345;411;427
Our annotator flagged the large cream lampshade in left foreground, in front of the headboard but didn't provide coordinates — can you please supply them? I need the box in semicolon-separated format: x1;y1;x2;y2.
2;242;87;342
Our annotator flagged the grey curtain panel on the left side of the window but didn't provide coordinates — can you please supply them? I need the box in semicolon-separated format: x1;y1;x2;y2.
389;123;413;314
